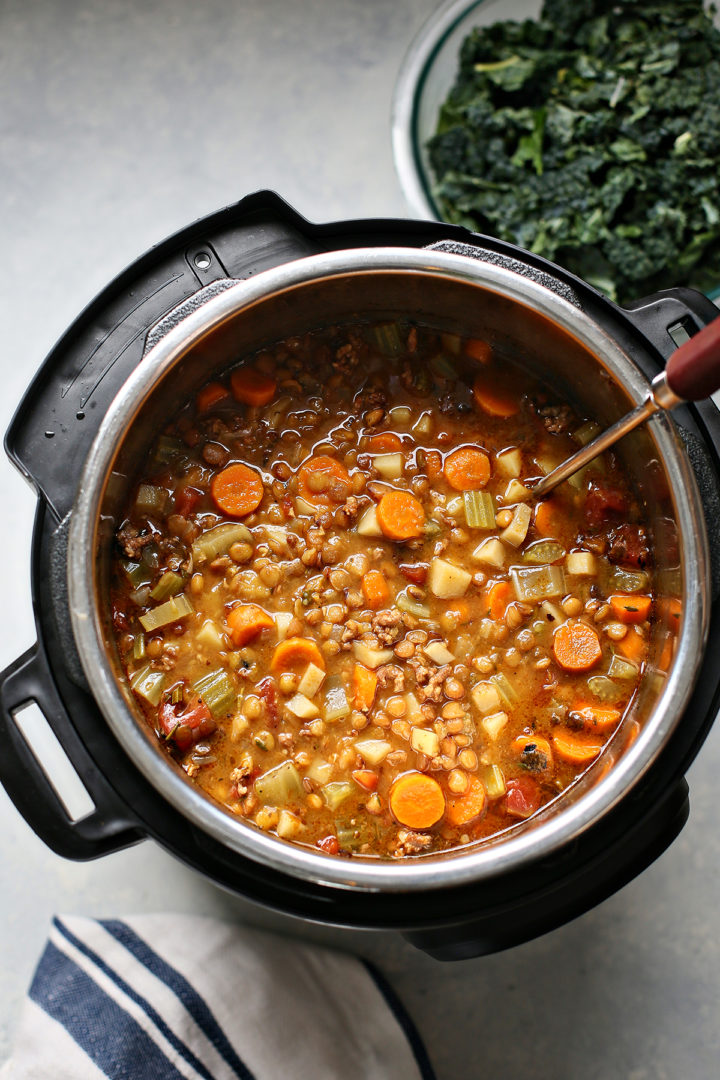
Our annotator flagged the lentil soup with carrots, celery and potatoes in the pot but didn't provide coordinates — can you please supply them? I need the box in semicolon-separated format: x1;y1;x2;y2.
111;320;660;858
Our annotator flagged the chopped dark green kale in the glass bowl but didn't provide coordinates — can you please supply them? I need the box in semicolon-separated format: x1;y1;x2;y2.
429;0;720;302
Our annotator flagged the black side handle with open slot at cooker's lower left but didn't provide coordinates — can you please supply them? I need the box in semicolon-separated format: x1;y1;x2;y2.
0;645;142;860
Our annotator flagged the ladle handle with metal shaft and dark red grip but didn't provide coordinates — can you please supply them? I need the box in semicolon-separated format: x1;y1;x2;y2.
532;316;720;499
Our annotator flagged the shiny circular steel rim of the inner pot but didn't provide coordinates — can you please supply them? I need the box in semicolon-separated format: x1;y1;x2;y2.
68;247;709;892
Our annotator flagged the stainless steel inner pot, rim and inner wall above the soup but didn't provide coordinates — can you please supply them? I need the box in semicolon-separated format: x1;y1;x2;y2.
68;247;709;891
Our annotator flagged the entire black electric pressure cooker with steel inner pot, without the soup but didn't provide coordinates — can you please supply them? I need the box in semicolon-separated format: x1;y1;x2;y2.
0;192;720;959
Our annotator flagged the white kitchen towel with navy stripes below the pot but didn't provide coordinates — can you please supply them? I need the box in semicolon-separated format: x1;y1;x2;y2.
0;915;434;1080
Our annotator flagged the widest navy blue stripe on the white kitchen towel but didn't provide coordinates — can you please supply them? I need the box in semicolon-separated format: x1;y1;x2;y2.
29;942;182;1080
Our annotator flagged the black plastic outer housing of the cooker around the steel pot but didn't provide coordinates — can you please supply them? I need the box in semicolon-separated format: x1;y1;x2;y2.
0;193;720;959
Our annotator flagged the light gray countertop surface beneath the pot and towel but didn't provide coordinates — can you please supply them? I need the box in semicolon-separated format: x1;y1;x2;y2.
0;0;720;1080
